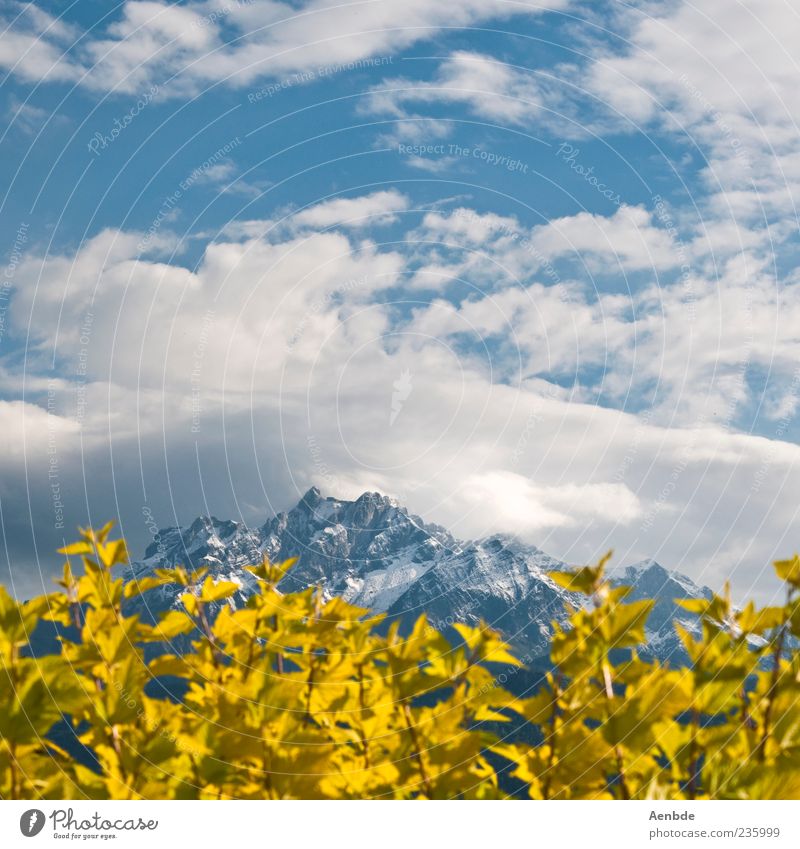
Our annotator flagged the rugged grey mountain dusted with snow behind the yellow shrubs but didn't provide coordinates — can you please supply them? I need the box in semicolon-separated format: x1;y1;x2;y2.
126;488;710;663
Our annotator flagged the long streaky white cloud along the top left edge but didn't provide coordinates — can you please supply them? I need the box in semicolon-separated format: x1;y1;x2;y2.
0;0;569;96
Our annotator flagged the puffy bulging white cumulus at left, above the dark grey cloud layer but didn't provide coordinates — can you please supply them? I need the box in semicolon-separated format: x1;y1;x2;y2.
13;225;399;396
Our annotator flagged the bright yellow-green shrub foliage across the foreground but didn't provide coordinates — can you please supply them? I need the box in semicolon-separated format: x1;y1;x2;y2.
0;525;800;799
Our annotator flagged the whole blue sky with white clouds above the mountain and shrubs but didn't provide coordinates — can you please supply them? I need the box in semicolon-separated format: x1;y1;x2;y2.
0;0;800;600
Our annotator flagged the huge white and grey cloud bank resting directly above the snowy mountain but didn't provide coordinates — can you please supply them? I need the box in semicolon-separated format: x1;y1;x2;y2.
0;200;800;604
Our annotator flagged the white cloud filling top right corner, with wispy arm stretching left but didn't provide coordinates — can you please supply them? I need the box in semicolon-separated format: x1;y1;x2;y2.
360;0;800;252
